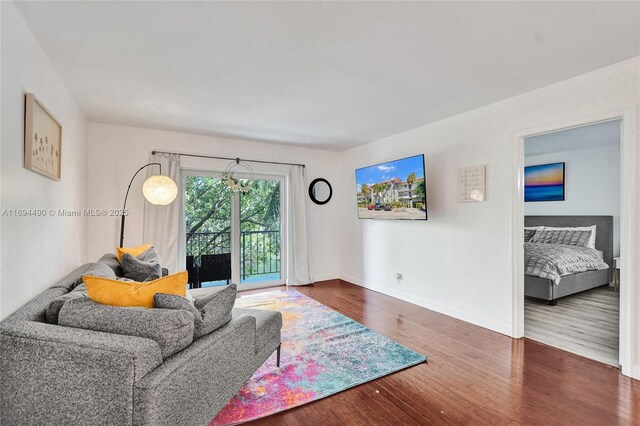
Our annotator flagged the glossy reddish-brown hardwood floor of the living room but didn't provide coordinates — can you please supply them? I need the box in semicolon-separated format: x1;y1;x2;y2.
246;280;640;426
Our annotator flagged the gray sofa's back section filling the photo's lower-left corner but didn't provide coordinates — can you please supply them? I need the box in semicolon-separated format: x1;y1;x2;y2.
0;321;162;425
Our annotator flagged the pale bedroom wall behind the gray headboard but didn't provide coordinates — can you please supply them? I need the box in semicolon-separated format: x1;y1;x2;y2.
524;143;620;256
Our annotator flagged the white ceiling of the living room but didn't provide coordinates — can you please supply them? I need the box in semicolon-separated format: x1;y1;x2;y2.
11;2;640;150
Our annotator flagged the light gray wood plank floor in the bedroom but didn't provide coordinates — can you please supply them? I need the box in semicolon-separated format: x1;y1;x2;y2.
524;285;620;367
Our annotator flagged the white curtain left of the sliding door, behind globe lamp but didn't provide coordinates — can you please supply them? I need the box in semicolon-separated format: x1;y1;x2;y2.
142;154;185;274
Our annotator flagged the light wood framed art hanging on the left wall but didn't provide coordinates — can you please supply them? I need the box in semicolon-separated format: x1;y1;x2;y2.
24;93;62;181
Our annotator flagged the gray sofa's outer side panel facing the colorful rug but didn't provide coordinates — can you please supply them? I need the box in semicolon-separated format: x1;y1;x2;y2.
134;315;262;426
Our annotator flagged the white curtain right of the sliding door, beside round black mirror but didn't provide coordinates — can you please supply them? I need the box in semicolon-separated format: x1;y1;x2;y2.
287;166;311;285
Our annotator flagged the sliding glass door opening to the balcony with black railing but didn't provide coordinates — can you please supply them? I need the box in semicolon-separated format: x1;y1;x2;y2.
184;171;284;289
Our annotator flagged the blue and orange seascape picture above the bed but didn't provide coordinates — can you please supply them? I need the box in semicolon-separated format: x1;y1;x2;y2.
524;163;564;202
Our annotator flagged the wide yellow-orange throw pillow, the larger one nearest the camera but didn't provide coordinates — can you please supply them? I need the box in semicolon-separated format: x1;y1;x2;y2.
82;271;188;308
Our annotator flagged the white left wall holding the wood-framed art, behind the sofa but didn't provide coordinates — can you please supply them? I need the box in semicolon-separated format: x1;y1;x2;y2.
0;2;87;318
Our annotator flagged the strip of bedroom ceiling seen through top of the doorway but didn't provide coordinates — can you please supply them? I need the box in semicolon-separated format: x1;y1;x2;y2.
524;120;621;156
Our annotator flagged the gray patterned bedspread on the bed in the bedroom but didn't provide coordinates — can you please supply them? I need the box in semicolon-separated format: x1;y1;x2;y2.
524;243;609;284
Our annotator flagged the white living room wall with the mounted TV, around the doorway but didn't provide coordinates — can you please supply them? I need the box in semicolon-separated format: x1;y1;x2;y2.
339;58;640;334
